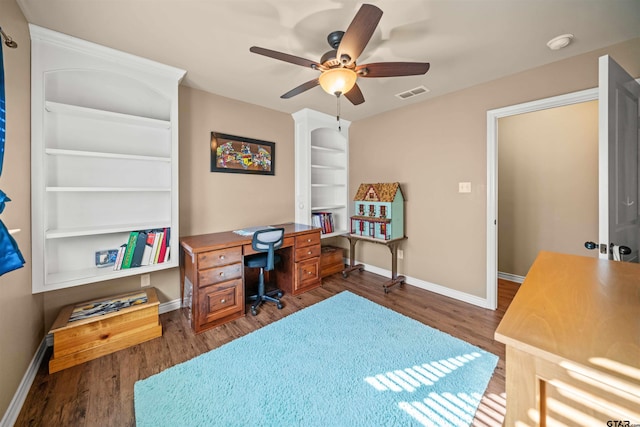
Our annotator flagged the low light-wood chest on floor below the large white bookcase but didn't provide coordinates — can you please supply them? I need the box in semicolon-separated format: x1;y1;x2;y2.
49;288;162;373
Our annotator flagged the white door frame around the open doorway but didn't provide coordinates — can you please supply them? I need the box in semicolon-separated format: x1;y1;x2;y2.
486;88;598;310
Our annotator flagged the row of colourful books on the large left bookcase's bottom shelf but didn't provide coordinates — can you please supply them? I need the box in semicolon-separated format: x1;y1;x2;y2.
113;227;171;270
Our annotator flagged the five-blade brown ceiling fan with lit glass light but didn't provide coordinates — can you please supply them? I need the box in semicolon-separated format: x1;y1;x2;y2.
249;4;429;105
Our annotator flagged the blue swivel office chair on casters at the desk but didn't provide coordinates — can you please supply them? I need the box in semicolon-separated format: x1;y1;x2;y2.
244;228;284;316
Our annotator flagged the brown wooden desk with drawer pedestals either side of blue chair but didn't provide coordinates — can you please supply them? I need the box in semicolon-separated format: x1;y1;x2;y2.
180;223;321;332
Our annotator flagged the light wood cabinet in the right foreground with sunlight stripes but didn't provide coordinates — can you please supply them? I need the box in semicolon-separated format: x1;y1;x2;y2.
495;252;640;426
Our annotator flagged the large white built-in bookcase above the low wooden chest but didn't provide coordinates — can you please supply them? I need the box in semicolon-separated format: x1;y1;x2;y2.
29;25;185;293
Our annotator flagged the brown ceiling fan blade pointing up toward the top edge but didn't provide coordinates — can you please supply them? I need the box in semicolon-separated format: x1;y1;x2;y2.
336;4;382;65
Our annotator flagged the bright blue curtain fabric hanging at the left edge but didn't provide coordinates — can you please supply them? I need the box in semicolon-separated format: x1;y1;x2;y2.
0;40;24;275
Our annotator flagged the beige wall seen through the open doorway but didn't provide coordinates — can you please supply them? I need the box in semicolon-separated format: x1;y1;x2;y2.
498;101;598;276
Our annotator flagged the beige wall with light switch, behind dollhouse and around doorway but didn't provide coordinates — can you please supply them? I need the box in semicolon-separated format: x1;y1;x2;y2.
349;39;640;298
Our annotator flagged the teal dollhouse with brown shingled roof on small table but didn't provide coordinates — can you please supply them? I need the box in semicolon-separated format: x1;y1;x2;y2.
351;182;404;240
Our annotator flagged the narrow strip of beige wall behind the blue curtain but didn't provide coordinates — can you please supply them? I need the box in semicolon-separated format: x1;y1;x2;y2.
0;0;44;418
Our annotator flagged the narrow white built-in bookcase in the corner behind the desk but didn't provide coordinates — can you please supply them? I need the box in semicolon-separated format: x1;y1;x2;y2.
293;108;351;238
